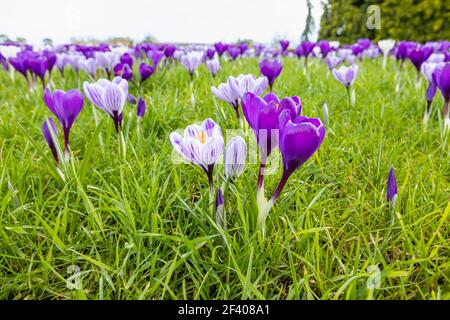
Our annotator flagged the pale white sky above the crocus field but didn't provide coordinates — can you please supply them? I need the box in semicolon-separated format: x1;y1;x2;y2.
0;0;322;44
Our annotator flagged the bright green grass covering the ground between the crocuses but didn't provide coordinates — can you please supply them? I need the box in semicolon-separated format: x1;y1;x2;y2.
0;59;450;299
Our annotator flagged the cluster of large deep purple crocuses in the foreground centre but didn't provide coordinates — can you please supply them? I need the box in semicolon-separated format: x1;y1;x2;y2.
242;93;325;227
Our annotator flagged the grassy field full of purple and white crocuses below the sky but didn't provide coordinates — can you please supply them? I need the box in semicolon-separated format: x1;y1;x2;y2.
0;39;450;300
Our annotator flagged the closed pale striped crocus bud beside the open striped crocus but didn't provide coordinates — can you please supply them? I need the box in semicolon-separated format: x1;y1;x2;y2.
224;136;247;179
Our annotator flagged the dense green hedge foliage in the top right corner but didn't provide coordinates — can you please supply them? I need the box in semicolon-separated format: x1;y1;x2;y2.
319;0;450;43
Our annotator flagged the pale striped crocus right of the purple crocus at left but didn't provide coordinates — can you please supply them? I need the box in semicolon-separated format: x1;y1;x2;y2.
83;77;128;133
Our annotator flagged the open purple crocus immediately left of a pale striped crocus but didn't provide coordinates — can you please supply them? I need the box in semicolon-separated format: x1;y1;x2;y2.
44;88;84;159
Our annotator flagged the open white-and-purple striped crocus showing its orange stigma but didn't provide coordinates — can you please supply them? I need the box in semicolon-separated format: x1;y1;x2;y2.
169;118;224;195
